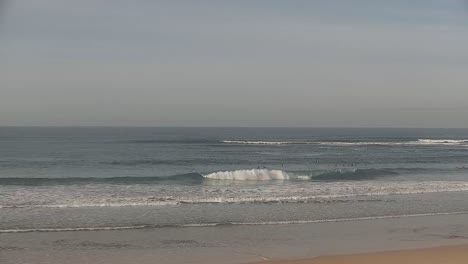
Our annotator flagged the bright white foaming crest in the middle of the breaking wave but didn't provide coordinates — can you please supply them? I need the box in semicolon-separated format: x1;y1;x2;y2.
203;169;290;181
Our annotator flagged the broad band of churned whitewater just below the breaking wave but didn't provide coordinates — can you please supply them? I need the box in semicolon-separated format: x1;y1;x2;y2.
5;181;468;210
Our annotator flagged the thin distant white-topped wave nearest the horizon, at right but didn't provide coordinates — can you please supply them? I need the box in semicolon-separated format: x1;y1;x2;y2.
221;139;468;146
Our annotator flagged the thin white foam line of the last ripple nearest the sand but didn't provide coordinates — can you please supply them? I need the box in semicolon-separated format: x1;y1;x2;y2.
0;211;468;233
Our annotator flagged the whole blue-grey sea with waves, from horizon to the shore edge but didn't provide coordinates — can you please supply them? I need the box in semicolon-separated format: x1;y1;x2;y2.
0;127;468;233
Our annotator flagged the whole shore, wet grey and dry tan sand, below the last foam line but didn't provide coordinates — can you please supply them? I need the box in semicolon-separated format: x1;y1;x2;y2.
0;214;468;264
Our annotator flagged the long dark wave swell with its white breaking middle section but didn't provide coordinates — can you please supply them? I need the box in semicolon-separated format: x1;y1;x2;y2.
0;167;465;186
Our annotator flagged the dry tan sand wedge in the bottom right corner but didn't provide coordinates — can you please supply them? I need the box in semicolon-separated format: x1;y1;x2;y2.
257;245;468;264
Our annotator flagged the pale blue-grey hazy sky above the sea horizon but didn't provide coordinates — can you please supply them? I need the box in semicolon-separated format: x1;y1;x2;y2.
0;0;468;128
